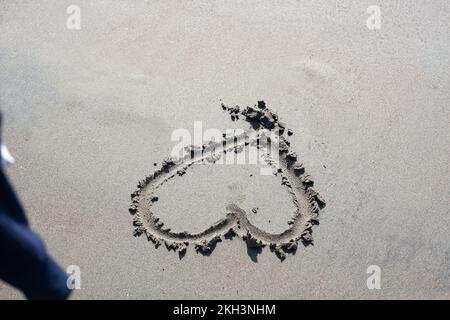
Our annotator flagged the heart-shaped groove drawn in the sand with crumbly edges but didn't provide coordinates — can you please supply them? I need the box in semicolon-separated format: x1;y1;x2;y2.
129;101;325;261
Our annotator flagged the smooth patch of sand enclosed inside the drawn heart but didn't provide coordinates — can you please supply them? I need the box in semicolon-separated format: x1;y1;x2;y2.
153;164;295;233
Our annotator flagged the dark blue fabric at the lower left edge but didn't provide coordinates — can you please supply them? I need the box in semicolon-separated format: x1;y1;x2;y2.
0;168;70;299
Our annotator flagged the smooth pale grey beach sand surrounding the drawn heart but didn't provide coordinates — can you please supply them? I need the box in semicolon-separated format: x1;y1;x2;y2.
0;0;450;299
